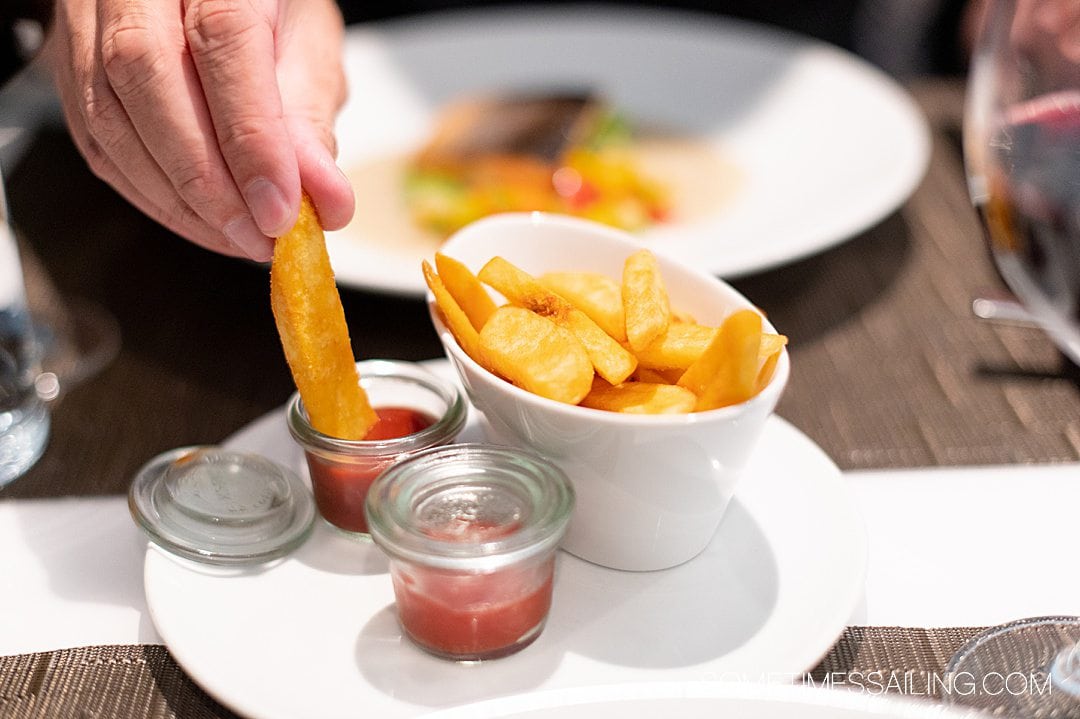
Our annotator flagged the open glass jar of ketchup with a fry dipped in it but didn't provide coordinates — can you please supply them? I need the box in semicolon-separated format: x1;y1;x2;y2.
287;360;468;539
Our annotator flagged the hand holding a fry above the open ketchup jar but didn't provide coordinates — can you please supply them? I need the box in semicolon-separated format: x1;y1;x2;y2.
44;0;353;261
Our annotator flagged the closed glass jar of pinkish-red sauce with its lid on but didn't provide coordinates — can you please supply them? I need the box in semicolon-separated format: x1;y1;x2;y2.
367;444;573;662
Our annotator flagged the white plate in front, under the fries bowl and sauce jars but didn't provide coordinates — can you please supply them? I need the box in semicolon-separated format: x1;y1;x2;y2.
144;362;866;719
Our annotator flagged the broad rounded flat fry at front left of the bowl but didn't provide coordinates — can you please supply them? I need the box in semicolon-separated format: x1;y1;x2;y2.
480;306;594;405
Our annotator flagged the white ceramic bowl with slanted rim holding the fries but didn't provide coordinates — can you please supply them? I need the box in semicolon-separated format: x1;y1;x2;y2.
428;213;789;570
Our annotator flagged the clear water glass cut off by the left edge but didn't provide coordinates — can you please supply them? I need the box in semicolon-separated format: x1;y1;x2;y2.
0;170;49;487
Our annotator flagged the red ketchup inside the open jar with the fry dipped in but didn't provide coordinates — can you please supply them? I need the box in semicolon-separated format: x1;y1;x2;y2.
307;407;435;532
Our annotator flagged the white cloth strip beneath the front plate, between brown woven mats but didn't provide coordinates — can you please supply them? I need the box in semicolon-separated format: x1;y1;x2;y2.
0;464;1080;655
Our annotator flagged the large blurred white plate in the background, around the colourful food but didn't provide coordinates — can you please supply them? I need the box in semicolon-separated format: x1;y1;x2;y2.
328;5;930;296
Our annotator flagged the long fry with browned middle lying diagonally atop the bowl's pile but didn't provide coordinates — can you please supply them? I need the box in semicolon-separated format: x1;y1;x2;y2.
477;257;637;384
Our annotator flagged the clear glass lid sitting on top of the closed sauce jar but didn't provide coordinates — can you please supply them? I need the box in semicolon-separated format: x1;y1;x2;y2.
366;444;573;571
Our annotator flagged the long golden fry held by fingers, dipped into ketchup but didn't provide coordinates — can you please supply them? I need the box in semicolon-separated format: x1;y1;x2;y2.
270;194;378;439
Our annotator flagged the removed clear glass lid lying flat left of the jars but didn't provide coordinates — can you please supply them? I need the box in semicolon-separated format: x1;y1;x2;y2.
127;447;315;565
